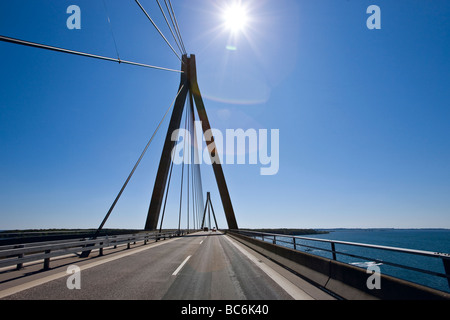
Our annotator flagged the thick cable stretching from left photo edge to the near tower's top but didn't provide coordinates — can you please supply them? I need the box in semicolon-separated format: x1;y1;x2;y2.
0;35;184;73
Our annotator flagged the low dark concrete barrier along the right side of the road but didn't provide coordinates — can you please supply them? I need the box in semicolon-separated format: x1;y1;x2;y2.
227;232;450;300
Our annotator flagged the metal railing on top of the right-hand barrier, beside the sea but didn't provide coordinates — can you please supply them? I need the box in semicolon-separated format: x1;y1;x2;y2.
230;230;450;288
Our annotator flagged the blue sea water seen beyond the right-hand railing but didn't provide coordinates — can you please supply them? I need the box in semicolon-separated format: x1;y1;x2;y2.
279;229;450;292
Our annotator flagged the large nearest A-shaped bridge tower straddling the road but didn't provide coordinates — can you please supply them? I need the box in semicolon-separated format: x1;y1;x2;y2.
145;55;238;231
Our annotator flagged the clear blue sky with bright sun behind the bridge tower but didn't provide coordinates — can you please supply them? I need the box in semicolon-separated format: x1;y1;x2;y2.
0;0;450;229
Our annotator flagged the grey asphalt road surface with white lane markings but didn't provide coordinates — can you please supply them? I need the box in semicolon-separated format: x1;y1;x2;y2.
0;232;330;300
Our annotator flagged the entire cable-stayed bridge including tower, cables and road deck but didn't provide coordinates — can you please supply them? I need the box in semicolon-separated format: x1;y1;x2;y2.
0;0;450;308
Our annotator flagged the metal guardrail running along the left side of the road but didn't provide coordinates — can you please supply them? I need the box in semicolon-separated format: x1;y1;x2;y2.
0;230;186;270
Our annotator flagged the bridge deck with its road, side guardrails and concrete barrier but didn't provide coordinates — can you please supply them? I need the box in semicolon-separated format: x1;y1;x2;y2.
0;229;450;301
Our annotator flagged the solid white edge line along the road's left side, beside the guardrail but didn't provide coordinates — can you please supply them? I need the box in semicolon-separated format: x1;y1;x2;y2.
0;238;181;299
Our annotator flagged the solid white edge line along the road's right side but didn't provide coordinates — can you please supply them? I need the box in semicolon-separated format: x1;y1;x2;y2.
225;236;313;300
